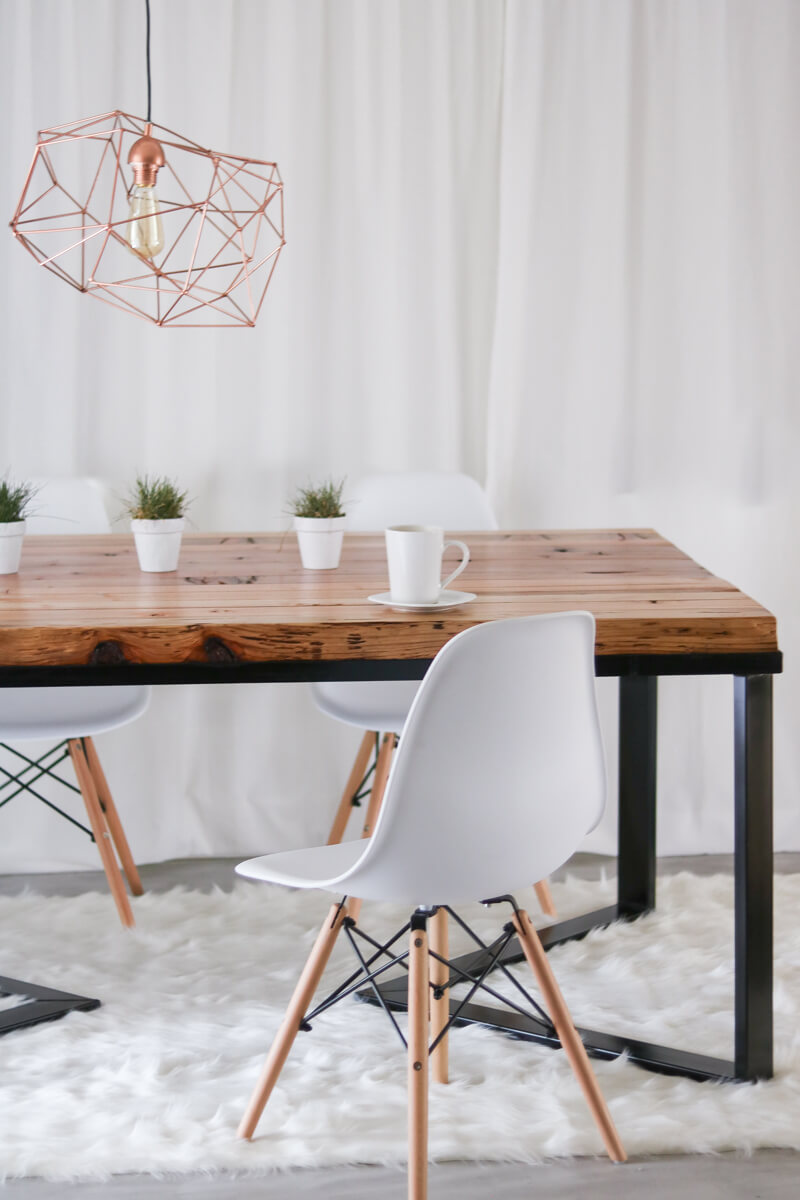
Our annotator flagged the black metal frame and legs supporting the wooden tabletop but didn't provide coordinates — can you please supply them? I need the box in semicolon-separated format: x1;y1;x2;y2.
0;643;782;1081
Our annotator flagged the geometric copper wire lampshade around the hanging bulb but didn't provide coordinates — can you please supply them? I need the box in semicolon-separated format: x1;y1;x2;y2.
11;110;285;328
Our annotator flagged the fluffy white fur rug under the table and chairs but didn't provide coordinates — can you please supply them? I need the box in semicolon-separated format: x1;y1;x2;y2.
0;875;800;1181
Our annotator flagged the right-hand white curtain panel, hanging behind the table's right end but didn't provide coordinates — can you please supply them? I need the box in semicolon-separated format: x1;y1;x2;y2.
488;0;800;853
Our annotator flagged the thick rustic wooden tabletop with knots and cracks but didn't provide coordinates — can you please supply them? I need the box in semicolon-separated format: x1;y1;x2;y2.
0;529;777;666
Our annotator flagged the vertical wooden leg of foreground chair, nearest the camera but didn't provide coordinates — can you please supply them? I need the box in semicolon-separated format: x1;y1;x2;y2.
408;929;431;1200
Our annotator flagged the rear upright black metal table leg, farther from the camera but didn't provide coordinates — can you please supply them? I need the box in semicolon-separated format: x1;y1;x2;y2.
616;676;658;917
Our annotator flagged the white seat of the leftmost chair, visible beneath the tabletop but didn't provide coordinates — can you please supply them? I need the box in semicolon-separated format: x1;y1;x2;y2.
0;686;150;742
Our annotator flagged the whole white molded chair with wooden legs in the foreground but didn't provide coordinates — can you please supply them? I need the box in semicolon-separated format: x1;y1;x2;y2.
237;612;625;1200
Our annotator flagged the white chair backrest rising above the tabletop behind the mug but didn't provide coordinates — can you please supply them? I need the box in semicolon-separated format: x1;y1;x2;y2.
345;470;498;532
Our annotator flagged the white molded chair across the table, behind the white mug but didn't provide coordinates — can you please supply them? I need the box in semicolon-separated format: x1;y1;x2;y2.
312;470;555;917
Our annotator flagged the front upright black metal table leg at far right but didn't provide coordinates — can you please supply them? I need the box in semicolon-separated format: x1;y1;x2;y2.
734;674;772;1079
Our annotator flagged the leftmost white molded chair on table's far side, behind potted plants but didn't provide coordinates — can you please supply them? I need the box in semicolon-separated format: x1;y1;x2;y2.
0;479;150;925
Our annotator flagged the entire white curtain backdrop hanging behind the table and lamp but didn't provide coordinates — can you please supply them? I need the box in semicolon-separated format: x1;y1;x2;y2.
0;0;800;871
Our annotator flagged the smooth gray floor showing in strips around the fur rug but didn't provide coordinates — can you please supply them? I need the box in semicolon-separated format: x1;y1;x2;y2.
0;854;800;1200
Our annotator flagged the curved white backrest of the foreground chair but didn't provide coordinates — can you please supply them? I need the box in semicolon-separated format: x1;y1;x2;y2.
342;612;606;905
